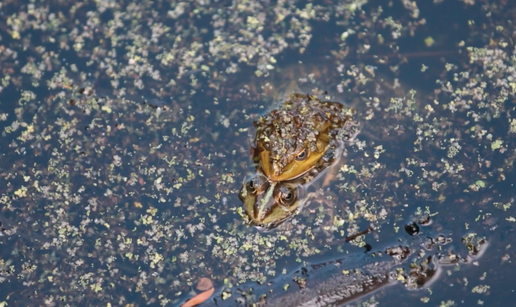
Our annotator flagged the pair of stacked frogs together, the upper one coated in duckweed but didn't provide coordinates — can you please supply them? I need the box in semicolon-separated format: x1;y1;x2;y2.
240;93;358;230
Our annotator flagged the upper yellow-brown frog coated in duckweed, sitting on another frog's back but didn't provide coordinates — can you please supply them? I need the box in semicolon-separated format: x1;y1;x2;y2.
252;93;357;182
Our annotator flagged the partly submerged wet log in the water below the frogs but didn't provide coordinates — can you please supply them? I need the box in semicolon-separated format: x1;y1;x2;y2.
207;219;488;307
